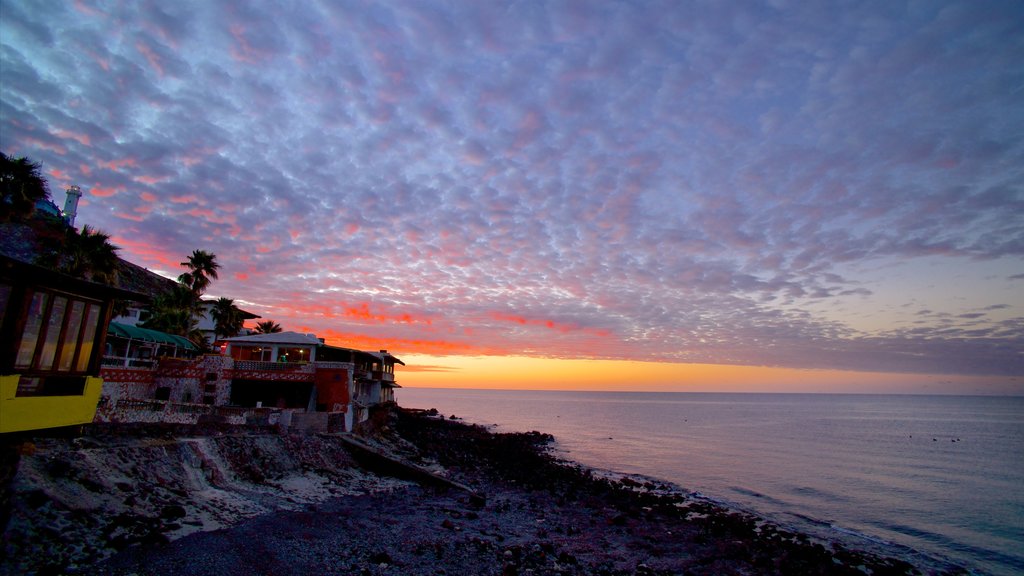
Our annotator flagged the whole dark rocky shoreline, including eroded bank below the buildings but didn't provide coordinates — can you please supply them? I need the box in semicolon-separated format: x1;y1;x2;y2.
0;408;958;576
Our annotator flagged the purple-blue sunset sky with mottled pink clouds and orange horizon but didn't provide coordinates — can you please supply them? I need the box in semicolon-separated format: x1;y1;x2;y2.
0;0;1024;394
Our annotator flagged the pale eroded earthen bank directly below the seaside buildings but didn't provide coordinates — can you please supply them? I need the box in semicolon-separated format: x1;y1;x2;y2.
0;426;410;575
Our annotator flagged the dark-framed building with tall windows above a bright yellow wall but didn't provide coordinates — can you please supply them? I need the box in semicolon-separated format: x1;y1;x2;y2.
0;255;145;433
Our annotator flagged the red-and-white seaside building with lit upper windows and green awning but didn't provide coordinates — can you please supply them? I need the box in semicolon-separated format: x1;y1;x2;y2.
96;328;403;431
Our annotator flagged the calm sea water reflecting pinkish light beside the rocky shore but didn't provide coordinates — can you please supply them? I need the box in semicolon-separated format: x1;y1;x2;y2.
397;388;1024;575
